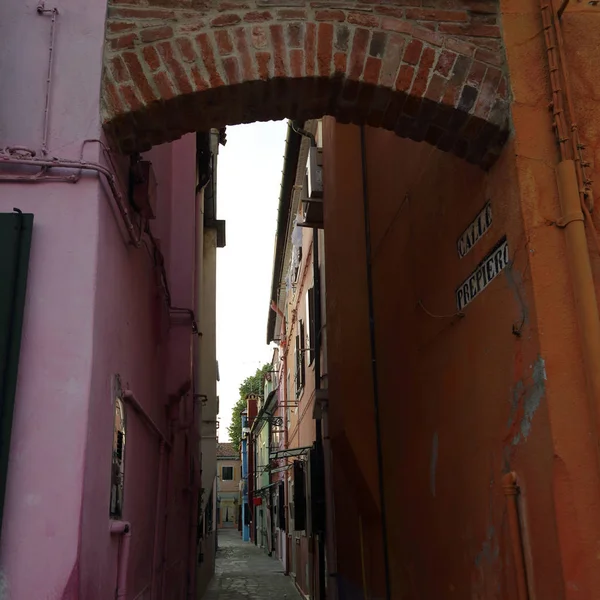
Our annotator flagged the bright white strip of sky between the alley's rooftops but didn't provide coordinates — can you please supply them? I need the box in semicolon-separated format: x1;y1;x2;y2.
217;121;287;442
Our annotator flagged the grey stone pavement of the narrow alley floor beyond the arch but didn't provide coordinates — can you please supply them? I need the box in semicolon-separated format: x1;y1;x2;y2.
202;529;300;600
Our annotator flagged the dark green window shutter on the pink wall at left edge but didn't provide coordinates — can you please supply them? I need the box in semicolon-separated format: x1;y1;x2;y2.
0;211;33;527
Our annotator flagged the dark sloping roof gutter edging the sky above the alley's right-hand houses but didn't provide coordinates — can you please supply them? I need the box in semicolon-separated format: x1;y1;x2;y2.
267;121;302;344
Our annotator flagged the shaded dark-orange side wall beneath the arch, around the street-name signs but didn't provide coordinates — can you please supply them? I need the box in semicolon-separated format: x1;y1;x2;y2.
325;121;561;600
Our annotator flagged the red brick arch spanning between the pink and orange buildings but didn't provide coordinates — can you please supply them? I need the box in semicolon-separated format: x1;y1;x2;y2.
102;0;509;167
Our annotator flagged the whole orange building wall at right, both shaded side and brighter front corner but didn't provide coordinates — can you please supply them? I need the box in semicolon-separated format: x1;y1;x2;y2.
324;0;600;600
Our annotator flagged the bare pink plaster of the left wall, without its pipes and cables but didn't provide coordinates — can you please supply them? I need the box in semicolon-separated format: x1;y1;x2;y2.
0;0;202;600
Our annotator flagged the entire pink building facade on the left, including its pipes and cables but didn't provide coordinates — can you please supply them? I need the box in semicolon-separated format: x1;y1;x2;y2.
0;0;219;600
